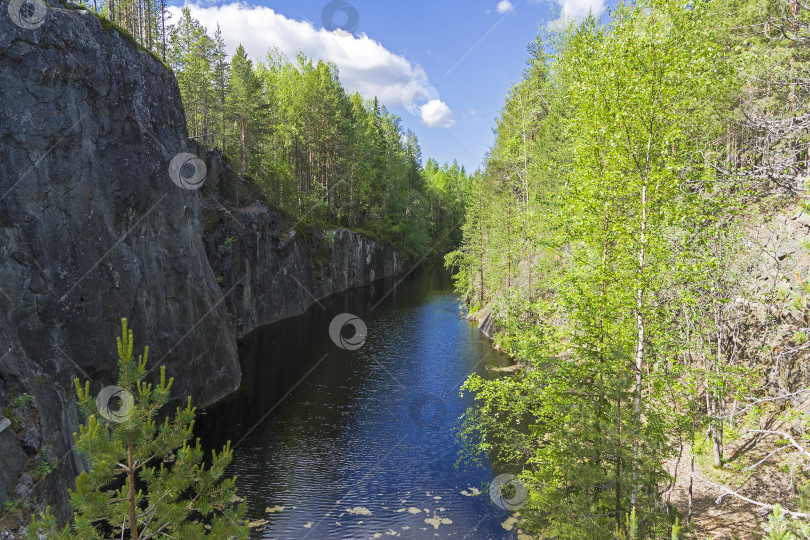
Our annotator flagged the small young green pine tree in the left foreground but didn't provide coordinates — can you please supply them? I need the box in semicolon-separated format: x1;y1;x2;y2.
27;319;248;540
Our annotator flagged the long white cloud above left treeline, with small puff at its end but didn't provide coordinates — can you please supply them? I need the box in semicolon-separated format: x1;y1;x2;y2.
169;0;453;126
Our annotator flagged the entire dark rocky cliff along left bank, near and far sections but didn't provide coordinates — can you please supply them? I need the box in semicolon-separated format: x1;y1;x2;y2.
0;5;402;532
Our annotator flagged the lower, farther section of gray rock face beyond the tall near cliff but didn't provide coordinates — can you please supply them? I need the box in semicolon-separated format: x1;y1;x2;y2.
193;152;404;337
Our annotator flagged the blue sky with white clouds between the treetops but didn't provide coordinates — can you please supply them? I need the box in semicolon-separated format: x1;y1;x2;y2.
169;0;615;172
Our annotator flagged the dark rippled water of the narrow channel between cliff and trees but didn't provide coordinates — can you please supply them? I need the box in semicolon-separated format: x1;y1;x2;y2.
197;268;512;539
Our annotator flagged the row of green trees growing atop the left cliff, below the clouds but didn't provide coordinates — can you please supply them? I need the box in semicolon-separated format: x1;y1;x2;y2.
159;8;469;257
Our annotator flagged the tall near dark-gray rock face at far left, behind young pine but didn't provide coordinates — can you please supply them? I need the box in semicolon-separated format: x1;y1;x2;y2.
0;0;240;514
